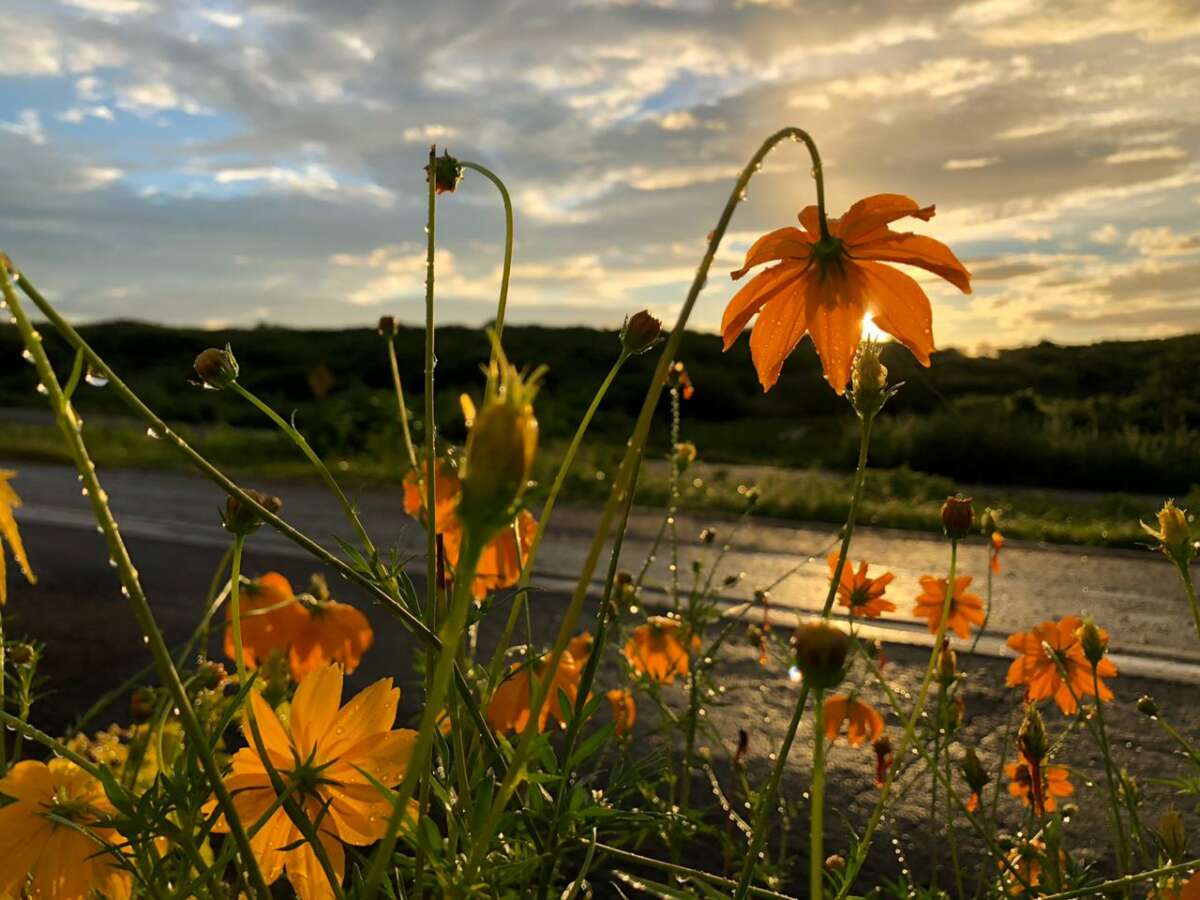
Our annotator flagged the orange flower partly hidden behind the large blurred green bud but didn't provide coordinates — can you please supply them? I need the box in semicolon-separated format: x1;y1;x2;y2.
404;462;538;600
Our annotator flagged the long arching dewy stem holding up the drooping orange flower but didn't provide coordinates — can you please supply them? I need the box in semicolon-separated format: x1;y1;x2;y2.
467;127;820;896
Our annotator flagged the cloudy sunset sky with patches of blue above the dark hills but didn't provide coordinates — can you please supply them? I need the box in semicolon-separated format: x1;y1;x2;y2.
0;0;1200;353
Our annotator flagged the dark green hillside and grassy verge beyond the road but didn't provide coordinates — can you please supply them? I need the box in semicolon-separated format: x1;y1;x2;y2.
0;322;1200;545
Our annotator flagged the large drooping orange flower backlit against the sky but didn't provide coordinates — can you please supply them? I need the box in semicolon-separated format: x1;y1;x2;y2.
721;193;971;394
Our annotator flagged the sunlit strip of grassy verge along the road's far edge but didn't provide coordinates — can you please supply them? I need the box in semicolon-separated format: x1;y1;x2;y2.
0;421;1171;547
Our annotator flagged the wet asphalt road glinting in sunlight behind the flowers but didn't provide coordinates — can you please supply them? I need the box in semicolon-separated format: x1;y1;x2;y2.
0;460;1200;892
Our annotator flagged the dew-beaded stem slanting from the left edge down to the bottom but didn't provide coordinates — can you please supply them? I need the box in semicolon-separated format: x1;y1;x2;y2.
0;263;270;898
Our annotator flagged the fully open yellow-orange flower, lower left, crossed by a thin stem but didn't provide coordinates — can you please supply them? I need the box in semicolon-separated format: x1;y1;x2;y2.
206;665;416;900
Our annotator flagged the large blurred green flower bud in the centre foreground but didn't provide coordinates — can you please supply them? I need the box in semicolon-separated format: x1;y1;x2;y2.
457;338;541;535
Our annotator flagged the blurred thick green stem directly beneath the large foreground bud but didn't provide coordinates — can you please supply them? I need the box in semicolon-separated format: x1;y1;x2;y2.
360;530;482;900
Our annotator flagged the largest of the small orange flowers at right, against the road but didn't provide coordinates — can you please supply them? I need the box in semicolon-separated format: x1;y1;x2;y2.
1006;616;1117;715
